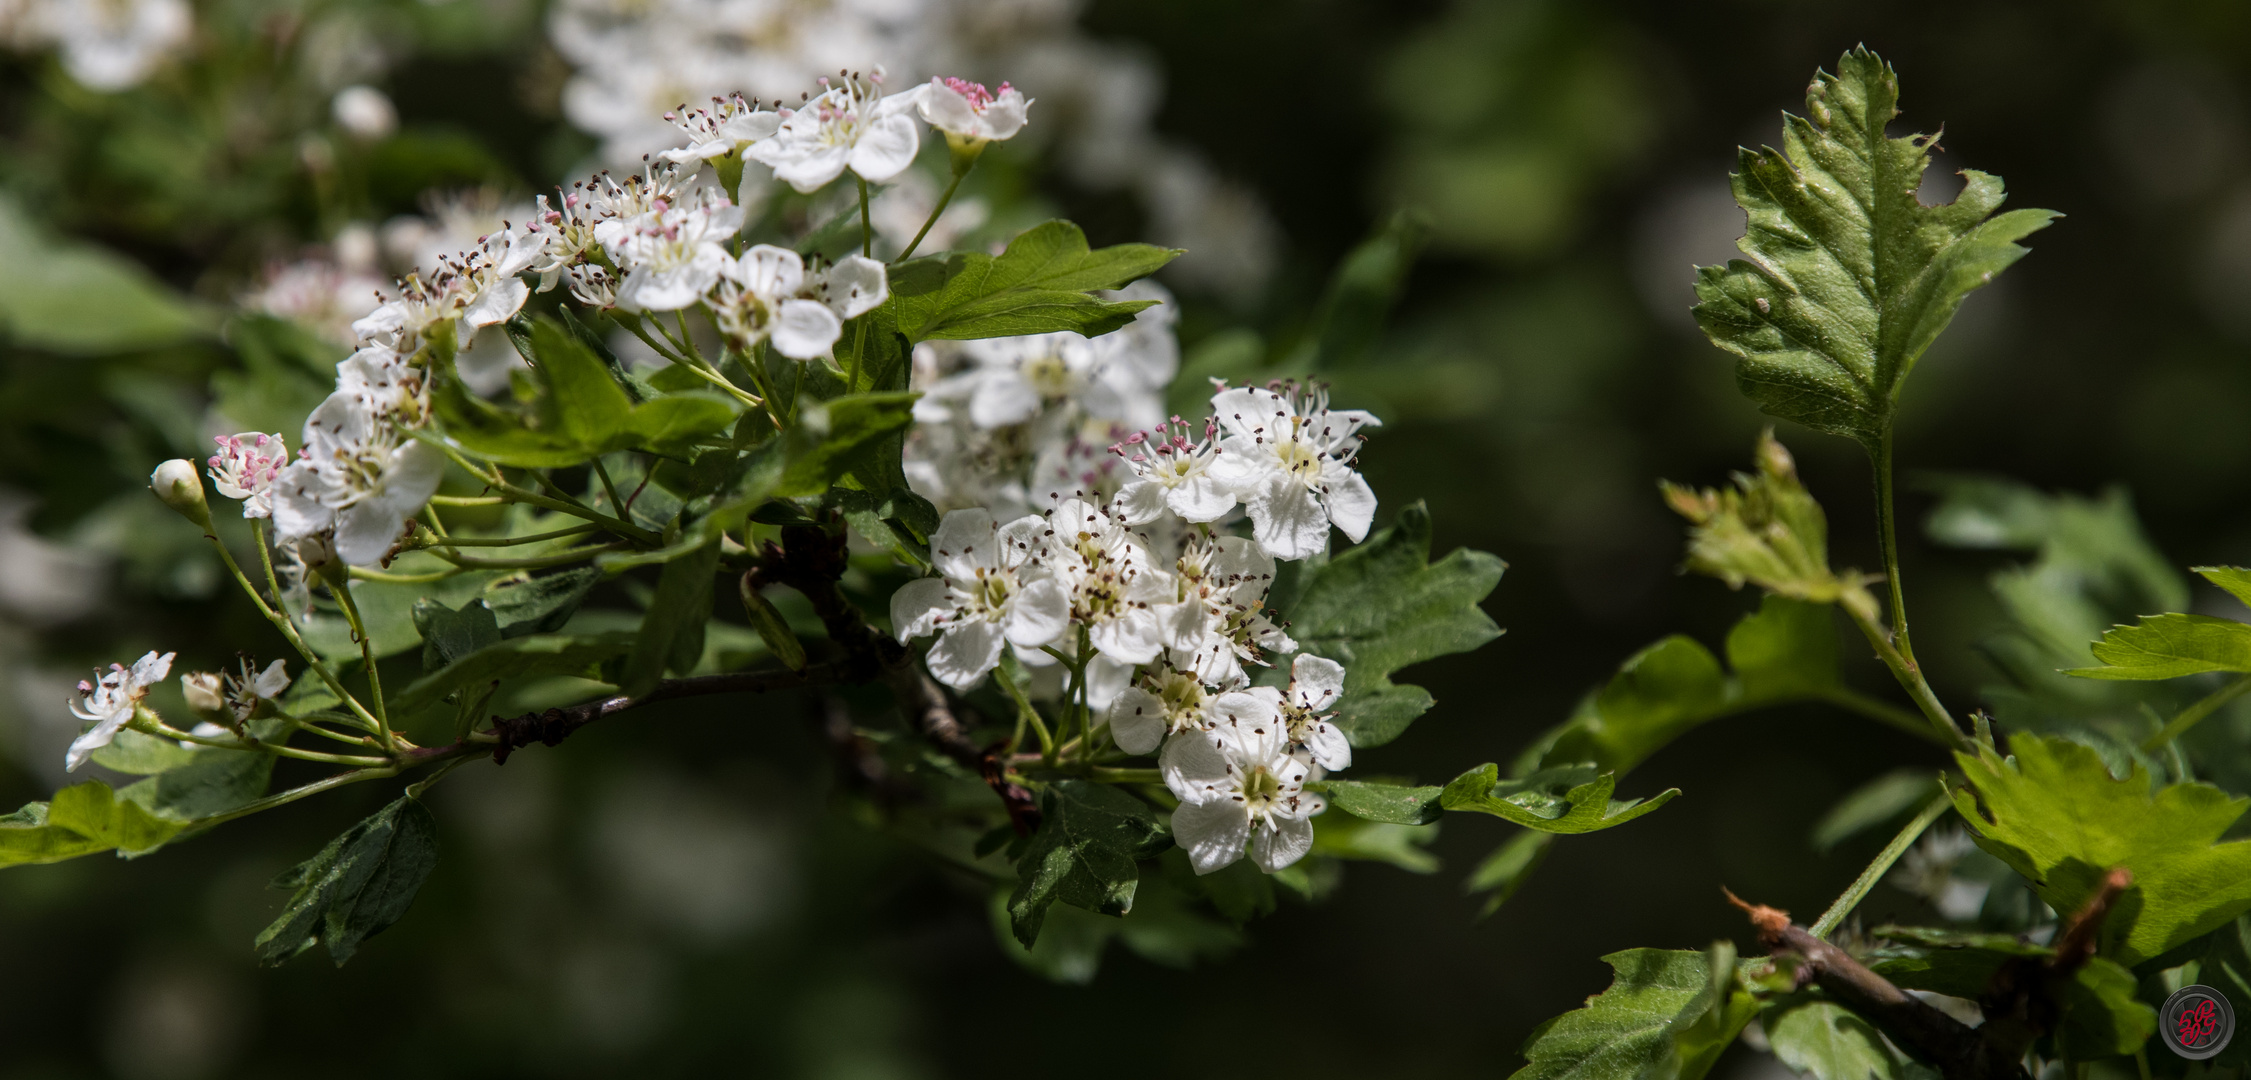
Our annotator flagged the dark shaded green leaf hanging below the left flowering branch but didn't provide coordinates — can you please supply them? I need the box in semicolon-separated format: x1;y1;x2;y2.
257;799;437;968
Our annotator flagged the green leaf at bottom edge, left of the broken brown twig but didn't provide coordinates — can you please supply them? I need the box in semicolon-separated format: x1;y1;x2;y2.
1510;941;1758;1080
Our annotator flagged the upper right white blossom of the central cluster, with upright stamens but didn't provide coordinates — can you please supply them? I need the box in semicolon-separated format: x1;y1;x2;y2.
1211;383;1382;560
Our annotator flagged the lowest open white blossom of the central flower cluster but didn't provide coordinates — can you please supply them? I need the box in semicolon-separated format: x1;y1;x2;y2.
1157;711;1328;873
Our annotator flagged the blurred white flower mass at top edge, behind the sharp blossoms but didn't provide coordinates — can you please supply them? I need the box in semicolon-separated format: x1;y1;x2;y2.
547;0;1279;297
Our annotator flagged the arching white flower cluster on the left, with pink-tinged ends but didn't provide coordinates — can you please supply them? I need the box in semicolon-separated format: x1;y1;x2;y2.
209;72;1029;565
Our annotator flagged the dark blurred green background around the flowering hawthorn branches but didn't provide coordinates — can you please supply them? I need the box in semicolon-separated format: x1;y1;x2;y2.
0;0;2251;1080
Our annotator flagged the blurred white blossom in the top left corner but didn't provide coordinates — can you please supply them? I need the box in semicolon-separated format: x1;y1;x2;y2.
0;0;196;90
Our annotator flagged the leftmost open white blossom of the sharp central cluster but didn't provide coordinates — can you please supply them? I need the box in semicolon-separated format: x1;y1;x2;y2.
891;509;1069;691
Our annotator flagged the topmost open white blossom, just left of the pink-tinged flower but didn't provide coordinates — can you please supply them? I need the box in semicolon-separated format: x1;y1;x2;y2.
743;70;925;191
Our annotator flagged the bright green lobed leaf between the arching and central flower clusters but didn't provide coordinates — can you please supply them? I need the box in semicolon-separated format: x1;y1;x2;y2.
887;221;1182;342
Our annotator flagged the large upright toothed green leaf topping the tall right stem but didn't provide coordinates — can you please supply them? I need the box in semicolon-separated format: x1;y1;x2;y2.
1695;47;2057;452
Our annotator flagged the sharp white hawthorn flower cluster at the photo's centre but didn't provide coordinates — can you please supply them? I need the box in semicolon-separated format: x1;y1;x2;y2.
891;366;1378;873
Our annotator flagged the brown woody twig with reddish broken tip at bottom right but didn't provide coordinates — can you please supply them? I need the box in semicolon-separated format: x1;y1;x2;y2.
1727;893;2026;1080
